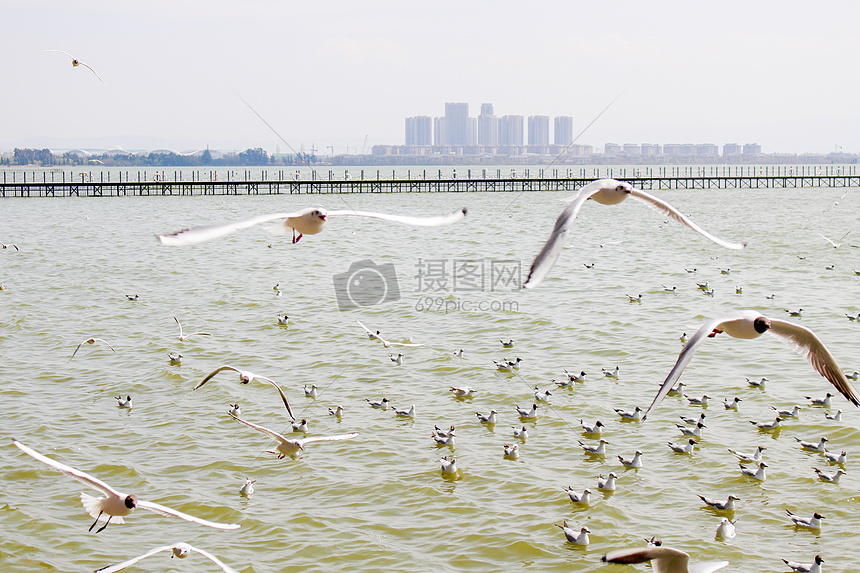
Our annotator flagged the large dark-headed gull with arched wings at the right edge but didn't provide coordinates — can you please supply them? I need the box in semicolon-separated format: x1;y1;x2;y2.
645;310;860;417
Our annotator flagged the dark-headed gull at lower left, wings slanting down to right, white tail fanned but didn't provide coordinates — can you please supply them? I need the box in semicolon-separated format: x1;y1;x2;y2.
12;438;239;533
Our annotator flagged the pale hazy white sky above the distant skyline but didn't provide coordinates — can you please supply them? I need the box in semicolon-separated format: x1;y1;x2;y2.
0;0;860;154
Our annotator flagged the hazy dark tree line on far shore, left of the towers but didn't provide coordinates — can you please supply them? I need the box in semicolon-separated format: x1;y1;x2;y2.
0;147;318;167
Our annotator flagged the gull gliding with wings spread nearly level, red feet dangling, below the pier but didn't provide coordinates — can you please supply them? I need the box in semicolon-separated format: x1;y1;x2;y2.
158;207;466;246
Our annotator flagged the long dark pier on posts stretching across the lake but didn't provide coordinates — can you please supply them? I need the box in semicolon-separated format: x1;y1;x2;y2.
0;175;860;197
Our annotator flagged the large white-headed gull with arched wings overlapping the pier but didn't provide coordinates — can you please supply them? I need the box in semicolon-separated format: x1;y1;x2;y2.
523;179;745;288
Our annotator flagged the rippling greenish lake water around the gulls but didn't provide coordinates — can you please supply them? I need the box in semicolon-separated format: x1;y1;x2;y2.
0;181;860;573
